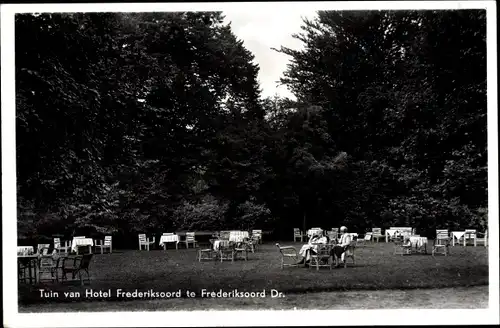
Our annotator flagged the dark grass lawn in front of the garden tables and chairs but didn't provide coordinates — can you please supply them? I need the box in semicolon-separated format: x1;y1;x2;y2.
19;242;488;312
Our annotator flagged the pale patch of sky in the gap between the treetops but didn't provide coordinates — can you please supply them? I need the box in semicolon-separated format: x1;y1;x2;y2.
223;8;316;99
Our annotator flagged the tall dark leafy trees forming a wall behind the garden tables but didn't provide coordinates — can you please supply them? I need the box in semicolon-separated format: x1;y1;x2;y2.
15;10;487;243
